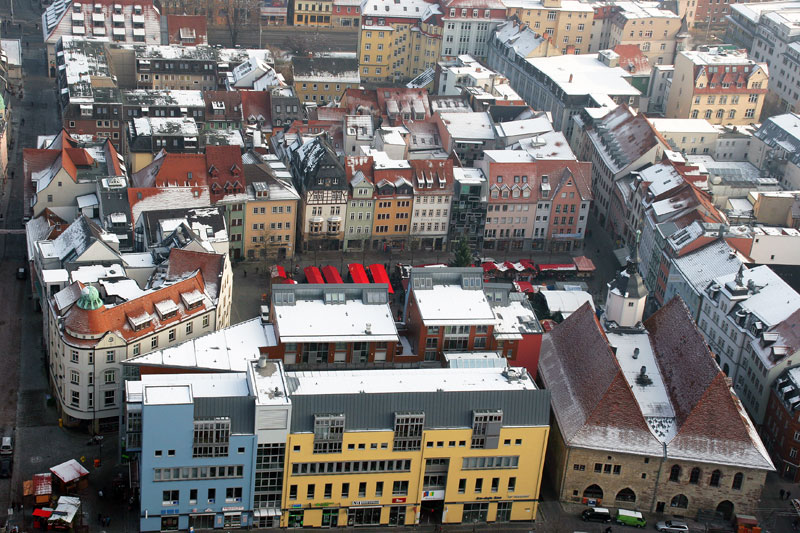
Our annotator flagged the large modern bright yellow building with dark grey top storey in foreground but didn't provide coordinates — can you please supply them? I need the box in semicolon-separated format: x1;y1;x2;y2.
281;368;549;527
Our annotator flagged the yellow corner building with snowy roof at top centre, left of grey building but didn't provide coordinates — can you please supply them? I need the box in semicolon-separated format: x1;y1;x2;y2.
358;0;442;83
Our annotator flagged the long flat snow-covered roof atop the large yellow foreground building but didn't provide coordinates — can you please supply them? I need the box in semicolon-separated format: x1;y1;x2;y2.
286;368;536;396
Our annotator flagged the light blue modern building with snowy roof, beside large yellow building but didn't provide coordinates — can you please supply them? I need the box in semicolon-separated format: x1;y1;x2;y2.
134;372;257;531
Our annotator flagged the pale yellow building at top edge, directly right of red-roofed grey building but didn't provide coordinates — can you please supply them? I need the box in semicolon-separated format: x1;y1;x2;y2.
504;0;597;55
